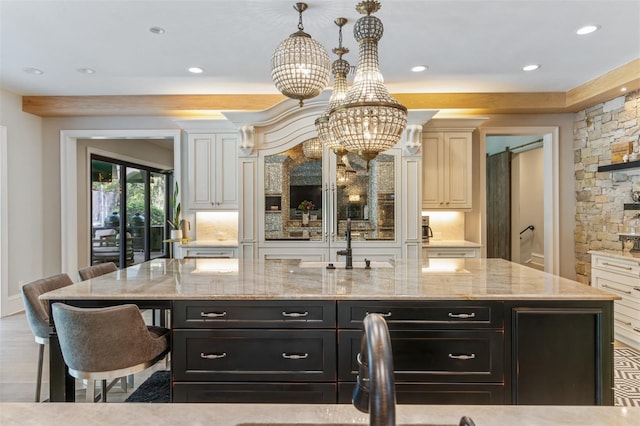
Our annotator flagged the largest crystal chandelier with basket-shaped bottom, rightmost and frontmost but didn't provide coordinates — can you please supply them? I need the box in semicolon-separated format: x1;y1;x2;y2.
329;0;407;165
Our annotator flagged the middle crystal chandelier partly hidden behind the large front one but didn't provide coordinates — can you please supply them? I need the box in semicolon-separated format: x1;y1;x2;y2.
315;18;351;156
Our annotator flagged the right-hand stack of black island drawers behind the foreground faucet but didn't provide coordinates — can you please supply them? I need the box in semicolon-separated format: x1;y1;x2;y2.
338;301;504;404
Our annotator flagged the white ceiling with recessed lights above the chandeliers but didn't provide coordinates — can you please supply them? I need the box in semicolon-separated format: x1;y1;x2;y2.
0;0;640;95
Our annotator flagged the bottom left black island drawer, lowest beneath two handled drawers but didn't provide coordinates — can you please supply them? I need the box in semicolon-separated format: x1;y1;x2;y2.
172;382;336;404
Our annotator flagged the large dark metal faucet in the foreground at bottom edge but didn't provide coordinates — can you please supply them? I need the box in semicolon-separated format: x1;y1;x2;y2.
352;314;396;426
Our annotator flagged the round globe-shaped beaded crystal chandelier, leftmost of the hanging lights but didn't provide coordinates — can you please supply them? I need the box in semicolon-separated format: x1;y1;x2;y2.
271;3;331;106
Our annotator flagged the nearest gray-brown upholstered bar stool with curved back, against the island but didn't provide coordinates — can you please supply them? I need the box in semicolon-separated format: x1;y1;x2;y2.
52;303;170;402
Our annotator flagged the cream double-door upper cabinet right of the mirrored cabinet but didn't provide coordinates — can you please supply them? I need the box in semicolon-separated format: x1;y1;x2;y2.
422;131;473;210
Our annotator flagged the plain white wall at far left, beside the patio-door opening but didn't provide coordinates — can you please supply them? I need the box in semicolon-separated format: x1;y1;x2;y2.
0;90;43;316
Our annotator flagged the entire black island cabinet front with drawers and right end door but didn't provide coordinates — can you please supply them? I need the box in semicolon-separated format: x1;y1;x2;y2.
172;300;613;405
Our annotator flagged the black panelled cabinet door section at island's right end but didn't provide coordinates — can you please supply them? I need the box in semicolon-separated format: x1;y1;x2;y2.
506;301;614;405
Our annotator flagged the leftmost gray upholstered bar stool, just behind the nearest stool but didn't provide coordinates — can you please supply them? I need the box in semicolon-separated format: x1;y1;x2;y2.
22;274;73;402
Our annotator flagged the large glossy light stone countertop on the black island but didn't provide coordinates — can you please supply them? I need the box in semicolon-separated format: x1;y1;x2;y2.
41;259;619;300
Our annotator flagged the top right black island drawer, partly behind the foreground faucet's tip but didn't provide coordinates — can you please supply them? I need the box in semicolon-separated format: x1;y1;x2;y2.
338;301;503;330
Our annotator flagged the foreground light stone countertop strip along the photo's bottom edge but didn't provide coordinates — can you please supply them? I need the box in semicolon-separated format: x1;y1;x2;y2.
0;403;640;426
